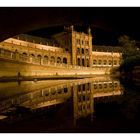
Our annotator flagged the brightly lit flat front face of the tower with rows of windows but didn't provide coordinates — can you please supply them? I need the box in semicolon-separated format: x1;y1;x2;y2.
71;28;92;67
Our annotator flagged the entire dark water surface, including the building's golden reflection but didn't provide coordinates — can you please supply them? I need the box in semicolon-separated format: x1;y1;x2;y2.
0;77;140;133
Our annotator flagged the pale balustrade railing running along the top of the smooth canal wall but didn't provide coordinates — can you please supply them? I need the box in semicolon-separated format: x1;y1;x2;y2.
0;49;119;70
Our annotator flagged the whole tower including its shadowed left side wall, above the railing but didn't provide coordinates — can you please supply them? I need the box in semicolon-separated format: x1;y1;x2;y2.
54;25;92;67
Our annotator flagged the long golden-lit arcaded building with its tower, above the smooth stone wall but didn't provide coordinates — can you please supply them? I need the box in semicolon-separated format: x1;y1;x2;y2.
0;26;122;77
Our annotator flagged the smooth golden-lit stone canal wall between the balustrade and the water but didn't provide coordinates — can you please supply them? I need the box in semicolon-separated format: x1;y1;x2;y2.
0;58;110;77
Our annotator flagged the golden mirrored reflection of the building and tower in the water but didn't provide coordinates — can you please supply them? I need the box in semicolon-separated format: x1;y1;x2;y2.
0;77;123;132
